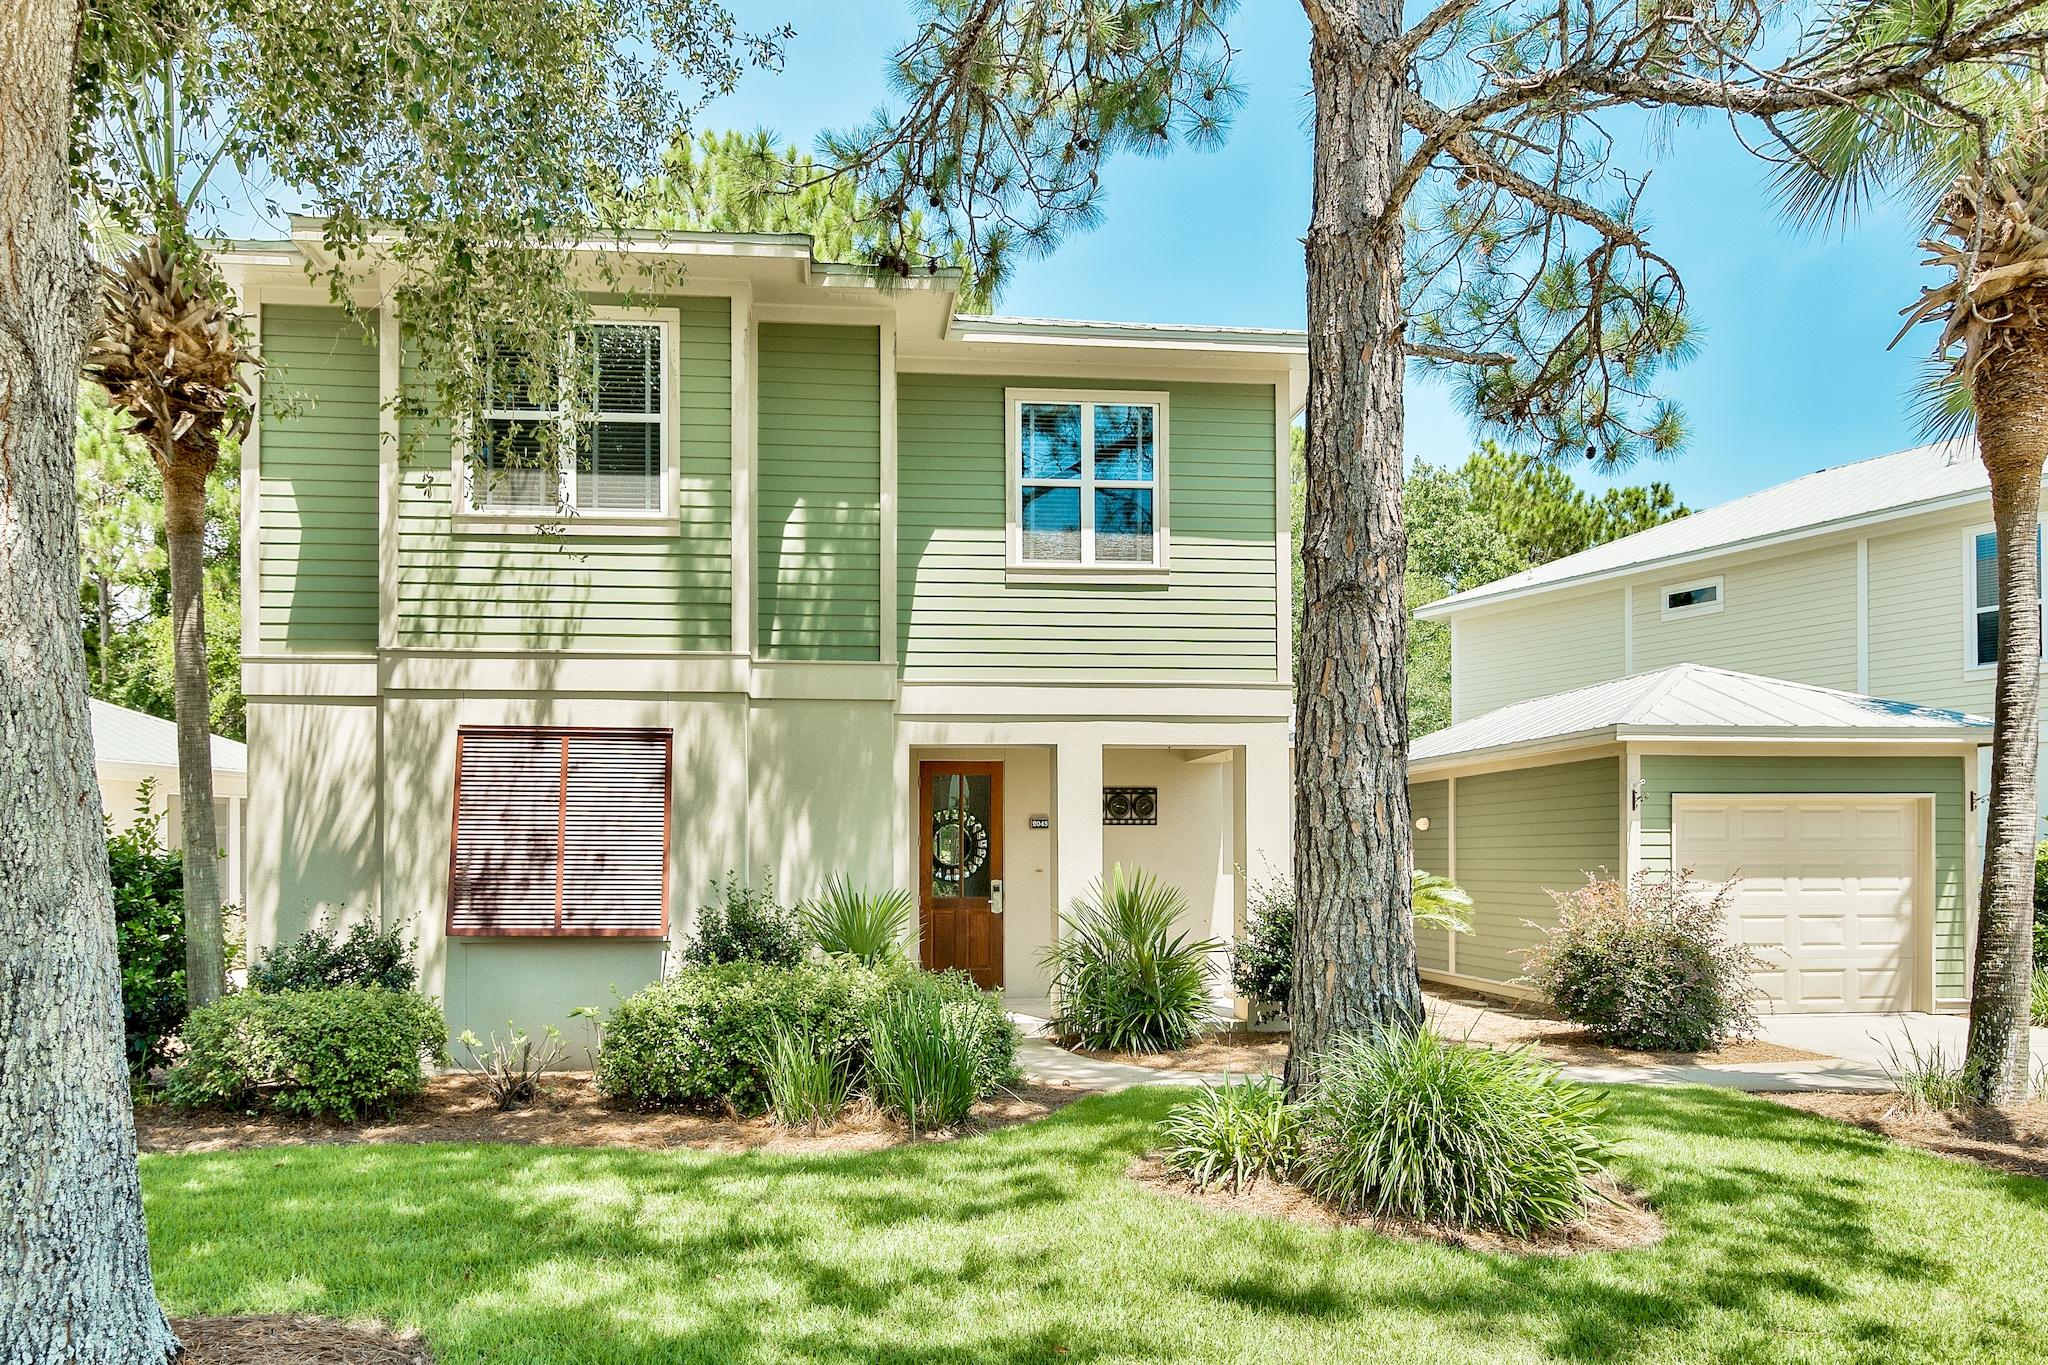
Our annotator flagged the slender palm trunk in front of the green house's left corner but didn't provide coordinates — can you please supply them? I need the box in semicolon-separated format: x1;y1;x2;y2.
162;450;227;1009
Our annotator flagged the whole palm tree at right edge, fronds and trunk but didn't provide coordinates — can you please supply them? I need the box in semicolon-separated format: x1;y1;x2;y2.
1778;0;2048;1103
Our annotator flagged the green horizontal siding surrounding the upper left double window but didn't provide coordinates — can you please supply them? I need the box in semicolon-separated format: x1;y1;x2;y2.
397;297;733;651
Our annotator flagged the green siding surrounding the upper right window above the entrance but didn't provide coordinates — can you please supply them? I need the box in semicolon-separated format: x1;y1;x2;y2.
897;375;1278;681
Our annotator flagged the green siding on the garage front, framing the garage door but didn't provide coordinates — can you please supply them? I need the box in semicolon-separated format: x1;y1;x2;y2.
1630;755;1968;1001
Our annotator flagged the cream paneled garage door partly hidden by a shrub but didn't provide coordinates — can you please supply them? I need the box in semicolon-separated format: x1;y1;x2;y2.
1671;796;1921;1013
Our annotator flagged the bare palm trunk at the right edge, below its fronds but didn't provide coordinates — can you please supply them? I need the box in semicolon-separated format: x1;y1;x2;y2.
1966;344;2048;1105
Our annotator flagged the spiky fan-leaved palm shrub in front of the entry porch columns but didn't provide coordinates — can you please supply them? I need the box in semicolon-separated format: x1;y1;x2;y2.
1044;866;1221;1052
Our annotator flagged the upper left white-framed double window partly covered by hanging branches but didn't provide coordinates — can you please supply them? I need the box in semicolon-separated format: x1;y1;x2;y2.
467;319;674;518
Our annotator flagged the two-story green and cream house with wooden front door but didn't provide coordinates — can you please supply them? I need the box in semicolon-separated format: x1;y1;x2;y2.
223;223;1307;1033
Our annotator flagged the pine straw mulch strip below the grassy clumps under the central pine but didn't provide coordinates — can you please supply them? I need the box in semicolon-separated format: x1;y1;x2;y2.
1128;1156;1665;1257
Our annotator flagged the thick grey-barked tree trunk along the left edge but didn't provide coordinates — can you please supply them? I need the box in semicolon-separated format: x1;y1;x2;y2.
0;0;178;1365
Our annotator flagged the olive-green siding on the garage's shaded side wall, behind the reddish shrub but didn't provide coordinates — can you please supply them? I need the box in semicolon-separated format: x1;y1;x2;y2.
1452;757;1622;982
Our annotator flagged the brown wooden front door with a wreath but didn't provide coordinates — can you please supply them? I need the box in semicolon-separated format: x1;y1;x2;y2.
918;761;1004;990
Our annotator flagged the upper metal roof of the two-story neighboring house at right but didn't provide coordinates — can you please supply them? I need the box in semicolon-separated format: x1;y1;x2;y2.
1415;438;1991;618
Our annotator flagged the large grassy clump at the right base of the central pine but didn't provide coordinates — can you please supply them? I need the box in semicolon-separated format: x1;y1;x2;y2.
1294;1025;1604;1236
